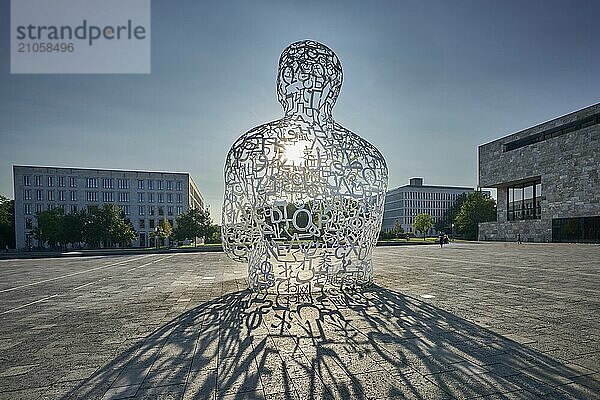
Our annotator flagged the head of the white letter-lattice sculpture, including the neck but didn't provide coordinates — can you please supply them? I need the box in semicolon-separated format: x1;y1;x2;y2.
277;40;342;121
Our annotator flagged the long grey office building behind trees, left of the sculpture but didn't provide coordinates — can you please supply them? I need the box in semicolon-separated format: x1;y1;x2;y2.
13;165;205;249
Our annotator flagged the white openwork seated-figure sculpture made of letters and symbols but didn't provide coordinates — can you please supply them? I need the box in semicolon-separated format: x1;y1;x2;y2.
222;40;387;293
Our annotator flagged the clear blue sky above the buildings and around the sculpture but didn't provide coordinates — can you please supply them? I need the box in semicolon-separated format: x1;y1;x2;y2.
0;0;600;220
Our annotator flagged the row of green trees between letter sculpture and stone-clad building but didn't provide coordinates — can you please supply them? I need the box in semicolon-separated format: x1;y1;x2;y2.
380;191;496;240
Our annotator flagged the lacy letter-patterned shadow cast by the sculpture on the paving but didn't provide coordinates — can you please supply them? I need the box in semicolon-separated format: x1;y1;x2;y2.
59;286;599;399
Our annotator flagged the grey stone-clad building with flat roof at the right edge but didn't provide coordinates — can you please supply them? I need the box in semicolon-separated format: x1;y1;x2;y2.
479;103;600;242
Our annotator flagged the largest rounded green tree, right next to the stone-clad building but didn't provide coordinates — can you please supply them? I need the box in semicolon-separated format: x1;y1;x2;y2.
455;191;496;240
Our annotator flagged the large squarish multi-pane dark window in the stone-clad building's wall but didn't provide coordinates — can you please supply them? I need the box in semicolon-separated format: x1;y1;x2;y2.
506;180;542;221
